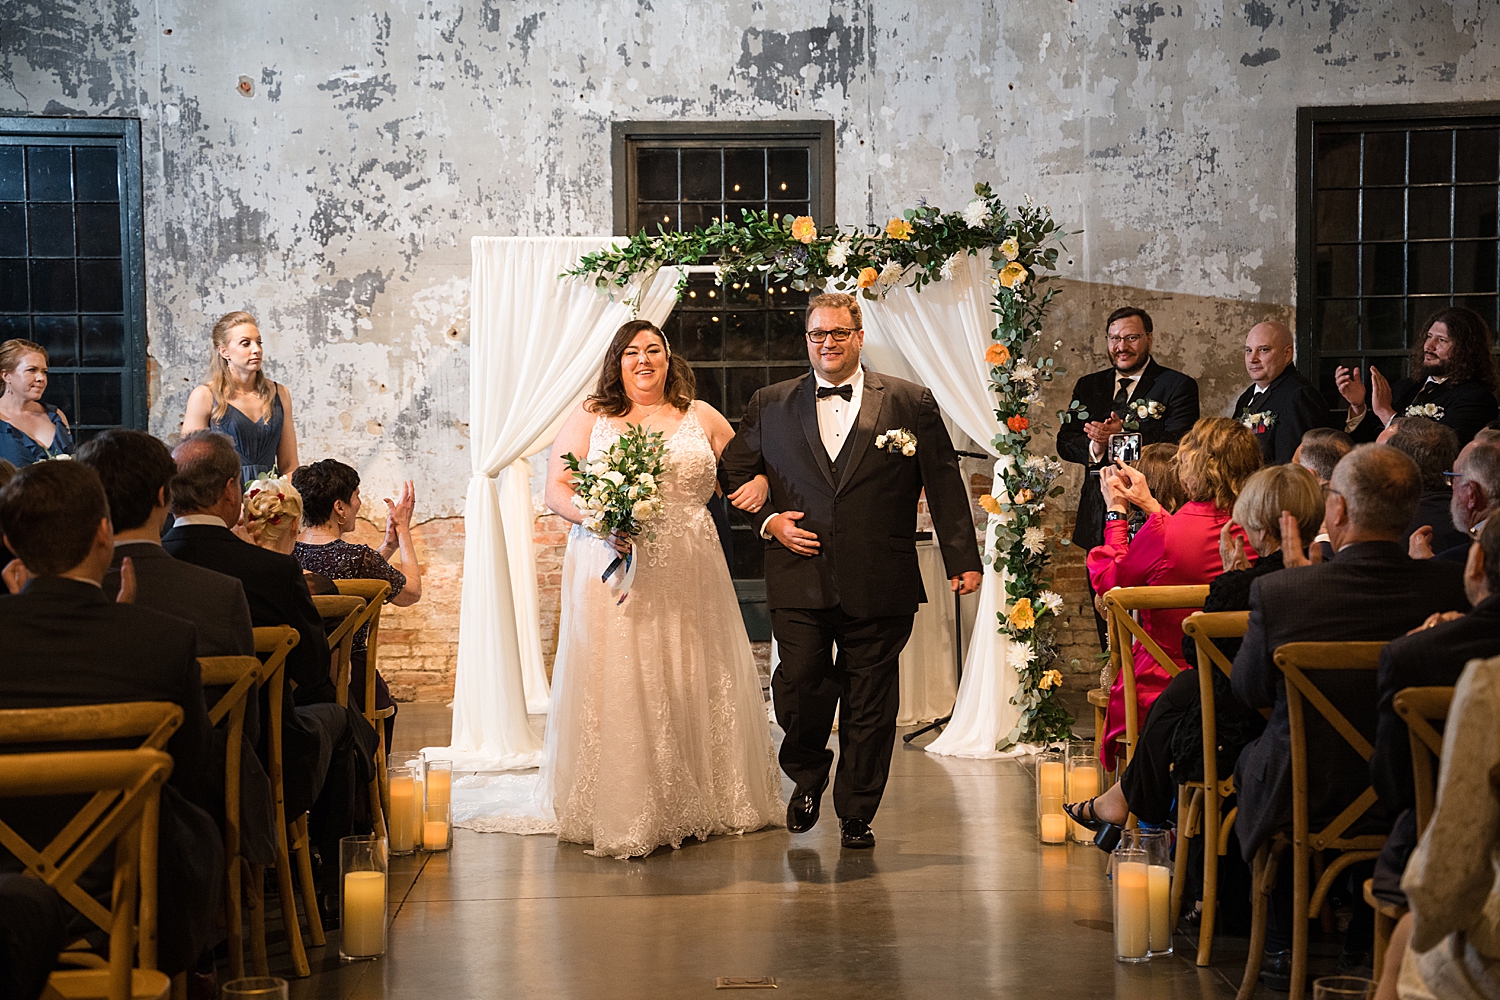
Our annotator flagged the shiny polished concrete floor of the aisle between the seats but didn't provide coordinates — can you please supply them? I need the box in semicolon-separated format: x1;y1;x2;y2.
291;705;1277;1000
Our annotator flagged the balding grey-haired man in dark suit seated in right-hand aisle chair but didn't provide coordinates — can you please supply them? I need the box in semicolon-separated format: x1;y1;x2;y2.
1230;444;1467;990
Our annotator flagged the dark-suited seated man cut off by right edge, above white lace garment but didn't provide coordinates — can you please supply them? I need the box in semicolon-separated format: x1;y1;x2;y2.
1370;519;1500;816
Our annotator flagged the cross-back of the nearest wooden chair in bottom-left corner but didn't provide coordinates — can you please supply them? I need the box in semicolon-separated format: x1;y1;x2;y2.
0;743;182;997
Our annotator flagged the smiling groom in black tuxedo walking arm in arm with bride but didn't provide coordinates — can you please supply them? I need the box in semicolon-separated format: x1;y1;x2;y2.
720;294;981;847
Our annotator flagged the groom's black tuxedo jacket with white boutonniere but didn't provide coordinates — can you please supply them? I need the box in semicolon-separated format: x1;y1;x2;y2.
720;370;981;618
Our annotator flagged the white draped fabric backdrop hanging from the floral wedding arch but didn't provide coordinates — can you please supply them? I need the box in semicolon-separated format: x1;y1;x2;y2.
438;237;1026;771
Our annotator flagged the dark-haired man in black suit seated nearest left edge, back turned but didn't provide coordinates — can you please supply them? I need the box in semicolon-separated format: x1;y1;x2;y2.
0;462;224;975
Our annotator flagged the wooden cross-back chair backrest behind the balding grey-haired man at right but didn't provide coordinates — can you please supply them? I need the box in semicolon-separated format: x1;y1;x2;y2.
1275;642;1386;850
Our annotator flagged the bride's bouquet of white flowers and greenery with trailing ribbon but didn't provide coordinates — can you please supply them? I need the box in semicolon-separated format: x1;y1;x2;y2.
563;426;666;601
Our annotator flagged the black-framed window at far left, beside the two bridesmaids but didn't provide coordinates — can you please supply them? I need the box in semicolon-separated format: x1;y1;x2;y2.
0;117;146;439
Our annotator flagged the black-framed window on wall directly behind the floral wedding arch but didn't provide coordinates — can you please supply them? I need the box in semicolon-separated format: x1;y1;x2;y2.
614;121;834;589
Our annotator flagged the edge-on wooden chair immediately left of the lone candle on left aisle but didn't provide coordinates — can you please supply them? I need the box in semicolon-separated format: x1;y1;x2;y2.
246;625;326;976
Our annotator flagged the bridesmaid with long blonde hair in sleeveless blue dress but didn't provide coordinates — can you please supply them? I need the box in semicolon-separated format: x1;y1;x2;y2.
183;312;297;483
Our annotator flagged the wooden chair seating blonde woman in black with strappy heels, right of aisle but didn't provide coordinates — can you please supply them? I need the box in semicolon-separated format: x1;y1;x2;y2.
1172;612;1250;966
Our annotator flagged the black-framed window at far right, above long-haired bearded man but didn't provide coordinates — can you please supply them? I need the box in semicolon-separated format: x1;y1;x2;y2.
1298;102;1500;408
